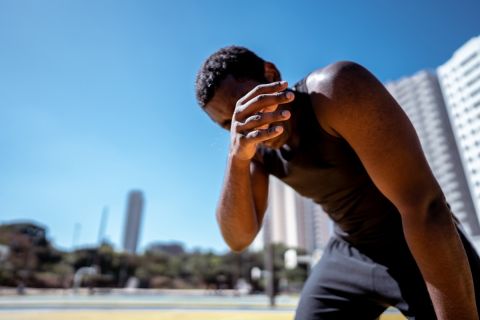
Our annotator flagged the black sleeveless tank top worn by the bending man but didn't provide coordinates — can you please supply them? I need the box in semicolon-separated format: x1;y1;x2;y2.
258;79;404;249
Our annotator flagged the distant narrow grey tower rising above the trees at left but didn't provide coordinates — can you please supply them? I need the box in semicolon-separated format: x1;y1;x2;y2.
123;191;144;253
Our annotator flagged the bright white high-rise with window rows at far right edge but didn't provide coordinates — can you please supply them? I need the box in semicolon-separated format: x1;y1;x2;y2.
437;36;480;240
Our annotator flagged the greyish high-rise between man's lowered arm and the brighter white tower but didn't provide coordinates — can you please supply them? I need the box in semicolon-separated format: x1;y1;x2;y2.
385;71;480;239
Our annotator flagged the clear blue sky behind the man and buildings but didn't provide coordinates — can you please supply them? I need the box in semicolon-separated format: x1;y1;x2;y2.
0;0;480;251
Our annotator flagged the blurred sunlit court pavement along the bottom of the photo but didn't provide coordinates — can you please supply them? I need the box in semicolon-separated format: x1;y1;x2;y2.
0;293;405;320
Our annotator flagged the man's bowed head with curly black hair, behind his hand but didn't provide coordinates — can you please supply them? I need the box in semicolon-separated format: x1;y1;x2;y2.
195;46;281;129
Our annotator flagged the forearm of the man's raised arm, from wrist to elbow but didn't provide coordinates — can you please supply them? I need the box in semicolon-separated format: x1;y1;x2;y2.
217;156;259;251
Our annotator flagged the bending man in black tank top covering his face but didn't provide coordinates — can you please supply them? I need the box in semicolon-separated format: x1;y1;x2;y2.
196;46;480;320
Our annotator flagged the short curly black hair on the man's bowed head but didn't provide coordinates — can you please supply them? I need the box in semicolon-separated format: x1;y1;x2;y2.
195;46;266;108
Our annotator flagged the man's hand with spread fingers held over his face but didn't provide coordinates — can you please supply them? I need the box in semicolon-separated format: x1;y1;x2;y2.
230;81;294;160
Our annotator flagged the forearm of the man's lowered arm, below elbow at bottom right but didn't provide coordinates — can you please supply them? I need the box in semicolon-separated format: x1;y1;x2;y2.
403;205;478;320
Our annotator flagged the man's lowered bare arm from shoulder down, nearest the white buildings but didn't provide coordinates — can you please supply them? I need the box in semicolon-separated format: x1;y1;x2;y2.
307;62;478;320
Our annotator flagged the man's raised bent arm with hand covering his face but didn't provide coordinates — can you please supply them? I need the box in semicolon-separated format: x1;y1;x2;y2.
217;82;293;252
